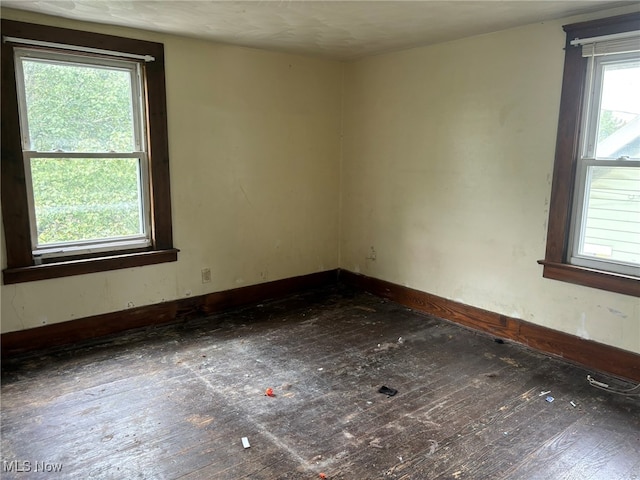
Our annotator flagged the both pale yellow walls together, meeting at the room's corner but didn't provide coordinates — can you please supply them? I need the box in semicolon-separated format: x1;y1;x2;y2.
2;6;640;353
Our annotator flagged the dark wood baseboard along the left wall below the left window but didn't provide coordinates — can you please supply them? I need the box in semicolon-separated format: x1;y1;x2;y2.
0;270;338;358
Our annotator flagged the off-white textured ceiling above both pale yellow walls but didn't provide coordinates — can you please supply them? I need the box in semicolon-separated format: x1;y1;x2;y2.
2;0;638;59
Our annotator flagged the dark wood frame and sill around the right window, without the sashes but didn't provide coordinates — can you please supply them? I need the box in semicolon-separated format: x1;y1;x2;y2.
539;13;640;296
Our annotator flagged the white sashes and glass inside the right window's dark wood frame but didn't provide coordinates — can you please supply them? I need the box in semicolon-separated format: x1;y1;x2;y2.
569;53;640;276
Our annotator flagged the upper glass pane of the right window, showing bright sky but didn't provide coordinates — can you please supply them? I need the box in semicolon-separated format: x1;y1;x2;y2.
596;60;640;158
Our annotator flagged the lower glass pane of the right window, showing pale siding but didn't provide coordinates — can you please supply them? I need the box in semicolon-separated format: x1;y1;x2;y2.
579;166;640;265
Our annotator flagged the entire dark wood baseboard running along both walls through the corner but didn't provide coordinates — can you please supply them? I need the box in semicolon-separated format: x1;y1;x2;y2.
0;270;640;381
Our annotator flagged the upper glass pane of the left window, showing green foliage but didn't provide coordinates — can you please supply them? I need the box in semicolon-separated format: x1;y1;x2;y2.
22;58;135;152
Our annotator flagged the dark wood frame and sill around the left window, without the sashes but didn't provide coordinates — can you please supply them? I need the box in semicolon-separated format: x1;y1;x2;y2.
1;19;178;284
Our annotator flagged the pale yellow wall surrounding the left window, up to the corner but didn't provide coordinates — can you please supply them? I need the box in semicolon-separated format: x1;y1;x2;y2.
2;10;343;332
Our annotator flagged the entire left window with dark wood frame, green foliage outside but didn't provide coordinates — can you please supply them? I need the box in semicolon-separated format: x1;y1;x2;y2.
2;20;177;283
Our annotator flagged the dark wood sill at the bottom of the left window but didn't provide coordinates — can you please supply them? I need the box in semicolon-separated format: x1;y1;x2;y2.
2;248;179;285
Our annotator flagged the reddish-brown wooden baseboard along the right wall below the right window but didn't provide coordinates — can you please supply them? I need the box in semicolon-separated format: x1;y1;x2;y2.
339;270;640;382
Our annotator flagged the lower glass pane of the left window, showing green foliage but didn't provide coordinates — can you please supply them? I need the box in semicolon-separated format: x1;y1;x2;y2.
31;158;144;246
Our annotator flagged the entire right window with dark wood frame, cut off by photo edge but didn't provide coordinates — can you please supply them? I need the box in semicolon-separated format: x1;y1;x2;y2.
540;14;640;296
